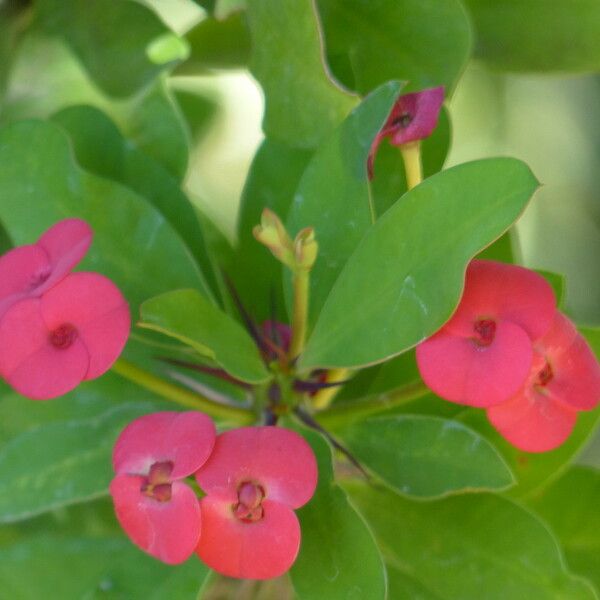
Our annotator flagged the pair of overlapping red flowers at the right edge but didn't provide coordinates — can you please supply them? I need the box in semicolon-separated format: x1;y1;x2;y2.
417;260;600;452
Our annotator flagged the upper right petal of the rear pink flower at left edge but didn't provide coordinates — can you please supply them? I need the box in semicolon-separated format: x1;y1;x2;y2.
37;219;93;291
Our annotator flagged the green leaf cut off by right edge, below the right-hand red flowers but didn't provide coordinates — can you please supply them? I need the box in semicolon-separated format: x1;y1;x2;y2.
530;466;600;590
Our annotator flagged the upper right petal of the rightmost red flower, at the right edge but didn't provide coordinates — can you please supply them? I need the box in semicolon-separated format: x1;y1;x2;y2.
536;311;600;410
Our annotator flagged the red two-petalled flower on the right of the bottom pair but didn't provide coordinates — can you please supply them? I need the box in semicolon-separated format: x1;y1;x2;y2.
196;426;317;579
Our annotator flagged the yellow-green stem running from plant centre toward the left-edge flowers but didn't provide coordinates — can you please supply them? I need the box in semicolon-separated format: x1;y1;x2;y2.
112;358;256;424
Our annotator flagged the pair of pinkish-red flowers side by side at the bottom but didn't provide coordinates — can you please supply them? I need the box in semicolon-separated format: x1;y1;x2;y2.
110;412;317;579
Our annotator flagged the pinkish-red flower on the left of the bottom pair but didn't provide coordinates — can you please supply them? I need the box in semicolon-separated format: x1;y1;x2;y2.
110;412;215;564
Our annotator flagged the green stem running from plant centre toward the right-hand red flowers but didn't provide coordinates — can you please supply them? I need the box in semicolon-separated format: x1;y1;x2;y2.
315;381;429;428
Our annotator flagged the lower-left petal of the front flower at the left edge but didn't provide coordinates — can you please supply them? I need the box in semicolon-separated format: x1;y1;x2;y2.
0;298;90;400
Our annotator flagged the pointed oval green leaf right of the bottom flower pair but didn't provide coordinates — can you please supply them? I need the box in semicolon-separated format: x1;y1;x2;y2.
335;415;514;498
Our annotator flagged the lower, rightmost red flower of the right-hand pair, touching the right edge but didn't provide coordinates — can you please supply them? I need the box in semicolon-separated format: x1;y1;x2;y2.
487;312;600;452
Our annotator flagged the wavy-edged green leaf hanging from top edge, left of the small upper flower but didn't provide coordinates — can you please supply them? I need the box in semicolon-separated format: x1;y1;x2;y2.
247;0;356;148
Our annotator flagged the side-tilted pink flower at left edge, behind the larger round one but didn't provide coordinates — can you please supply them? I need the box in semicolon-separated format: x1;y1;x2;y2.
0;219;92;317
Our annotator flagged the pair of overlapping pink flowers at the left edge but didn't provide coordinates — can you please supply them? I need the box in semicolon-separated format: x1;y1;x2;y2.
0;219;130;400
